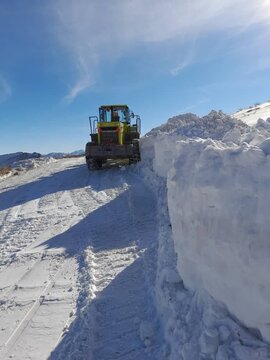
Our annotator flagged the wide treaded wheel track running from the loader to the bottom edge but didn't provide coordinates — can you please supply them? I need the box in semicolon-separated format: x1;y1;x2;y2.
50;170;165;360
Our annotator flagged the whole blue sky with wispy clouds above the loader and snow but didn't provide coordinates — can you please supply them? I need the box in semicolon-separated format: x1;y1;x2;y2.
0;0;270;154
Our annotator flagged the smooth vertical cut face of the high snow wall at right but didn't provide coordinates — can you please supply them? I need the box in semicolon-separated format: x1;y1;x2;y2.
141;134;270;341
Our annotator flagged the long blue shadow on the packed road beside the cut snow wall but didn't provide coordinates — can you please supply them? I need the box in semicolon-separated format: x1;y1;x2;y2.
39;179;160;360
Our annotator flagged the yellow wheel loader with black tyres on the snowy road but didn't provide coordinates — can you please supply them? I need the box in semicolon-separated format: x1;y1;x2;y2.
85;105;141;170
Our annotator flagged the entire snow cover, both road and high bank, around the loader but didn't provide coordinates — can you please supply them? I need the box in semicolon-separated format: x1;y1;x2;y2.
0;111;270;360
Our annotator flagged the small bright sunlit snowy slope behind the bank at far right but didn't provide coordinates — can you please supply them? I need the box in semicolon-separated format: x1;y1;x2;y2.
232;101;270;126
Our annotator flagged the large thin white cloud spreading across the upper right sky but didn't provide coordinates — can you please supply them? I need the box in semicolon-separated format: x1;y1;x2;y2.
51;0;270;101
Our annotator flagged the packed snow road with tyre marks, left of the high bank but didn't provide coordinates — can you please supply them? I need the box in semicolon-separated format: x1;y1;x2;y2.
0;159;163;360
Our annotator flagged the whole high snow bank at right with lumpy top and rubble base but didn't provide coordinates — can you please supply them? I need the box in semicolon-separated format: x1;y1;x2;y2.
137;112;270;359
